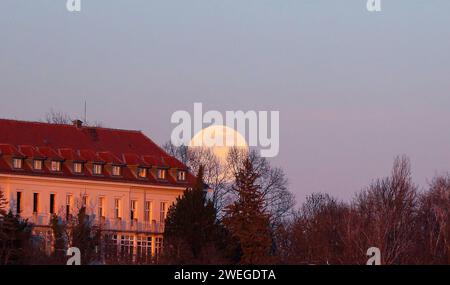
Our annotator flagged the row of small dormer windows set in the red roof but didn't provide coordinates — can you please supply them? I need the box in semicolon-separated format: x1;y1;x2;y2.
13;158;186;181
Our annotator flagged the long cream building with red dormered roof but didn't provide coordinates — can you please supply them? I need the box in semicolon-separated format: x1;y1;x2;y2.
0;119;195;260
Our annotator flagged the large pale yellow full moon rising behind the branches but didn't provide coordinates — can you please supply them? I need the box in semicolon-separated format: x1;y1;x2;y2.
189;125;248;164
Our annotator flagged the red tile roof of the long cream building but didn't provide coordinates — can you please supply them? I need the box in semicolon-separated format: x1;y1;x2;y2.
0;119;195;187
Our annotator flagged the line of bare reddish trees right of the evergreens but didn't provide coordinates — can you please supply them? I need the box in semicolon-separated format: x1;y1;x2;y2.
277;157;450;265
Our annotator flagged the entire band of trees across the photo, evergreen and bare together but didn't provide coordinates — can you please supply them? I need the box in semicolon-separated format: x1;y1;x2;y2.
0;149;450;265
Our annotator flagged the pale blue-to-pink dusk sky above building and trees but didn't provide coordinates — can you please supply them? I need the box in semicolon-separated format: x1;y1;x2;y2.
0;0;450;201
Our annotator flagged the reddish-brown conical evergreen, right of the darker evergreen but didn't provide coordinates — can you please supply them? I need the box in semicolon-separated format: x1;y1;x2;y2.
223;159;272;264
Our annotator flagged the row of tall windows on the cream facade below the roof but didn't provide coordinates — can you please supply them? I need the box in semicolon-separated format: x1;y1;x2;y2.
16;191;168;223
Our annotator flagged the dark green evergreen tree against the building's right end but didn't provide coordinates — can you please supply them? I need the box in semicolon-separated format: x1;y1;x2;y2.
164;167;225;264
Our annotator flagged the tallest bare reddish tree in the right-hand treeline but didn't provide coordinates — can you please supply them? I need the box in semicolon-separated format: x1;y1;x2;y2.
353;157;417;265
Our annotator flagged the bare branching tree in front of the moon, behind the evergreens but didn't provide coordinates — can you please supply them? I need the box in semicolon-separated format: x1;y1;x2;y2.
163;142;295;224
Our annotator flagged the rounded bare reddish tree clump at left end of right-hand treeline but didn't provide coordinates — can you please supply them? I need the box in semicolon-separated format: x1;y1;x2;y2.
277;193;349;264
